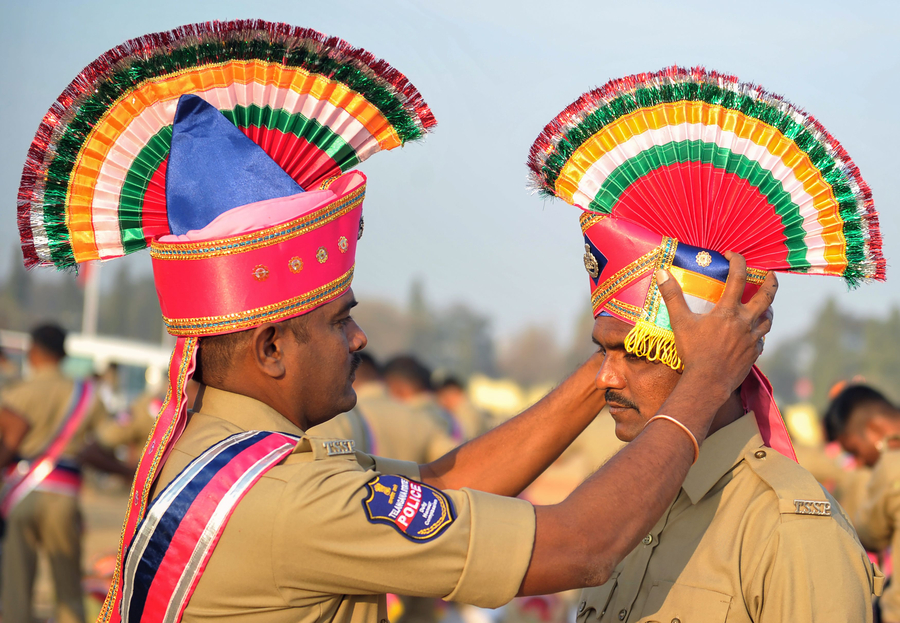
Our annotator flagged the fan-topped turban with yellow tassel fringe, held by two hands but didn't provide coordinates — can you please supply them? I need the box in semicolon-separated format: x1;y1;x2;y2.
528;67;885;370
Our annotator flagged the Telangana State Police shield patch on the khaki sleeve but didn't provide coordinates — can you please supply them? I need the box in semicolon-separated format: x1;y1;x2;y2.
363;474;456;543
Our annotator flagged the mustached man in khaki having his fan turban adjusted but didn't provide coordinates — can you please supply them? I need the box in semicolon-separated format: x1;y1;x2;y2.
529;67;884;623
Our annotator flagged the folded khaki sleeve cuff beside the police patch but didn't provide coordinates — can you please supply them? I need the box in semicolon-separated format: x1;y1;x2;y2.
445;489;535;608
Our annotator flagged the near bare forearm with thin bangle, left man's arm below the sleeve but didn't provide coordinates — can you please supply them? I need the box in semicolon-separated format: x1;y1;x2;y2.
521;374;728;595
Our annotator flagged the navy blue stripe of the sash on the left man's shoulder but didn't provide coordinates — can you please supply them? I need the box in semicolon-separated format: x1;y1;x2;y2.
123;431;290;621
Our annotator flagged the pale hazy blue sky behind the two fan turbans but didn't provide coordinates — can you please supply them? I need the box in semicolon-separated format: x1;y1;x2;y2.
0;0;900;343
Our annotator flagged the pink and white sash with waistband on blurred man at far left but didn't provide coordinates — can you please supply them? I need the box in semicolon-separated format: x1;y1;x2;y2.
0;381;94;518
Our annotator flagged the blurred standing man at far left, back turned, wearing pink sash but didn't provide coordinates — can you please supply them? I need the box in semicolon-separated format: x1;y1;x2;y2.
0;324;133;623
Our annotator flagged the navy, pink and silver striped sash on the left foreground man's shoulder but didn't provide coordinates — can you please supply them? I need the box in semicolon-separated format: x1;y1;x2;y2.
121;431;299;623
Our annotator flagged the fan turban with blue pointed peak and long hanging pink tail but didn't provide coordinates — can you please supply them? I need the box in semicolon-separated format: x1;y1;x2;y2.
18;21;435;621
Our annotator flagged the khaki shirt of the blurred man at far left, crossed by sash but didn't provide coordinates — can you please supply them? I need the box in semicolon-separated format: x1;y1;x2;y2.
0;367;109;461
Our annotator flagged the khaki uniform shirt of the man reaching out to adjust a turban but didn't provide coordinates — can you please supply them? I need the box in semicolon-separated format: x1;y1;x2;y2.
156;388;535;623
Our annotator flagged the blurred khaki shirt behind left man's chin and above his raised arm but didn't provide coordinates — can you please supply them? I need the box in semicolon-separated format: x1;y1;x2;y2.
307;383;457;465
